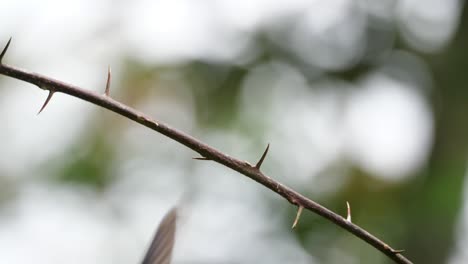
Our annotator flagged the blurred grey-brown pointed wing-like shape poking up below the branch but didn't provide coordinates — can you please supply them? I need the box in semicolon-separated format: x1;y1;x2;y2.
142;208;177;264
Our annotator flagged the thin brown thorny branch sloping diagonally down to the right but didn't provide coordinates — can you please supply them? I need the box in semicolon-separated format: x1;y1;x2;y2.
0;39;412;263
